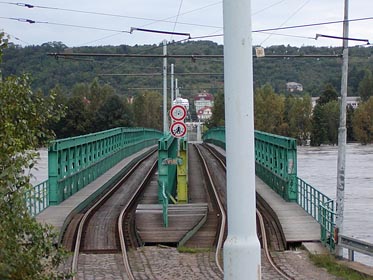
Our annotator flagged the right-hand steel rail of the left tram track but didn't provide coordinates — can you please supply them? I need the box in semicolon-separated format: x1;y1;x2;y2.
118;160;157;280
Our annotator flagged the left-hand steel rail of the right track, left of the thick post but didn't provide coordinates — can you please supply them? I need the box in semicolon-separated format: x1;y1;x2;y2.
195;145;227;274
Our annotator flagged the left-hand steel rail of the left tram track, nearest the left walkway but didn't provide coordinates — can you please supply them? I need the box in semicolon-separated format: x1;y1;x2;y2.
71;150;155;280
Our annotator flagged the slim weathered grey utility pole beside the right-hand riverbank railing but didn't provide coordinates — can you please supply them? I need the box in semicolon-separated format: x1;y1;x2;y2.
335;0;349;257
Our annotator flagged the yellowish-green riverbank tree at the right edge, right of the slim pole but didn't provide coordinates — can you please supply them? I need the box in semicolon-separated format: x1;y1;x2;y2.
352;97;373;144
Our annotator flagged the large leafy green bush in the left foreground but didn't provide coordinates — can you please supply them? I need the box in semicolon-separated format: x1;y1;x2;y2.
0;34;68;280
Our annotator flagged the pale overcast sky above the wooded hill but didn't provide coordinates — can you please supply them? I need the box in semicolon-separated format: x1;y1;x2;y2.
0;0;373;47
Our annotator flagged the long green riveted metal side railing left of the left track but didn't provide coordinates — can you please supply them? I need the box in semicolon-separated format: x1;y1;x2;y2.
48;128;163;205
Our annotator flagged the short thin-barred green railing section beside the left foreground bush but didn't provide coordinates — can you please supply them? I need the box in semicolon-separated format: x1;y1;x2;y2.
25;180;49;216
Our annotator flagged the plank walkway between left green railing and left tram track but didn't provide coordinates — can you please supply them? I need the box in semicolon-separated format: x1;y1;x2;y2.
36;146;155;233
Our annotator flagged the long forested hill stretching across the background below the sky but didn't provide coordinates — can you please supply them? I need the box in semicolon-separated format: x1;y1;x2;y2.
0;41;373;98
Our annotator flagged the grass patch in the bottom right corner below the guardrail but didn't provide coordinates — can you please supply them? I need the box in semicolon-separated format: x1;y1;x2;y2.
310;255;373;280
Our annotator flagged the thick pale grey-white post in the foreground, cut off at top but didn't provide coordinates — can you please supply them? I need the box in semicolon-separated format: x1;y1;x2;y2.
223;0;261;280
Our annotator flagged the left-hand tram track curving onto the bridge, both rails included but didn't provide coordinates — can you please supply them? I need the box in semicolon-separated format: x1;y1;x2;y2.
64;153;157;279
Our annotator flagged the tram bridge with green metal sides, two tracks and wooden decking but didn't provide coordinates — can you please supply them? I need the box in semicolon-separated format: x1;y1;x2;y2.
31;127;335;279
